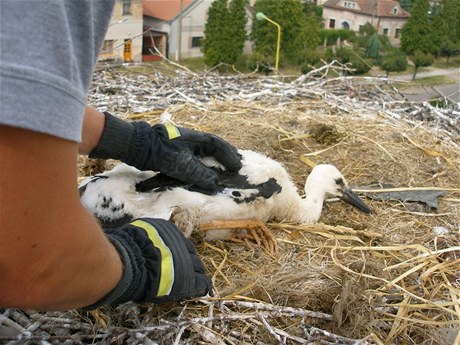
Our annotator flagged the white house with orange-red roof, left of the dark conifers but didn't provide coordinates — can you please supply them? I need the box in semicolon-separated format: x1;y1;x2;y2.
143;0;252;61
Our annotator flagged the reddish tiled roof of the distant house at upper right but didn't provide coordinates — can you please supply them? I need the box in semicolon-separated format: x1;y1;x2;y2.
323;0;409;17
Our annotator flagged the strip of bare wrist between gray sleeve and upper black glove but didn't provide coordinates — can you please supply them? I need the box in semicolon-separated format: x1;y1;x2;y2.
78;106;105;155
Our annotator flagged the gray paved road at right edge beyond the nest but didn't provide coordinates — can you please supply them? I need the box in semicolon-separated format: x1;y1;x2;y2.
390;67;460;103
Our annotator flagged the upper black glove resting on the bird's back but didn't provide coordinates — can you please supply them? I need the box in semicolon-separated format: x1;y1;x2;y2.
89;112;241;191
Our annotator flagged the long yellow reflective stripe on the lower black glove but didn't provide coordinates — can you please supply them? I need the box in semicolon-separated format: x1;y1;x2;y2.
131;220;174;297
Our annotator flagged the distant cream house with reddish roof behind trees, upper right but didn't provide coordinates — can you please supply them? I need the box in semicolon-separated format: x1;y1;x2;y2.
323;0;409;46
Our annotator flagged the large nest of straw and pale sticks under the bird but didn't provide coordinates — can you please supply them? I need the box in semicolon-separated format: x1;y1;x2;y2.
0;64;460;345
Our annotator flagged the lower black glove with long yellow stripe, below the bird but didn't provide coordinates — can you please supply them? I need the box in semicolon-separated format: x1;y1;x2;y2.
84;218;212;310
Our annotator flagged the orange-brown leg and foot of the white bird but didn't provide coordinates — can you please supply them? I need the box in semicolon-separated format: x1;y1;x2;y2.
199;219;278;253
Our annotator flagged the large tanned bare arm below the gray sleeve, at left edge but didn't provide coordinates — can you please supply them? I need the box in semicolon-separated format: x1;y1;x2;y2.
0;126;122;310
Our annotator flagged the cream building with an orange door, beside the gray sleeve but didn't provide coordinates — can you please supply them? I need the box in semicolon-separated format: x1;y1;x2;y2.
99;0;143;62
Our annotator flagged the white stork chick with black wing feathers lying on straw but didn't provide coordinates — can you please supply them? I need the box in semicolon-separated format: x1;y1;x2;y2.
79;150;370;251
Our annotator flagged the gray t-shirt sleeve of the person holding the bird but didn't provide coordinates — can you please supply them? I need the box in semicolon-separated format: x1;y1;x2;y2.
0;0;114;142
